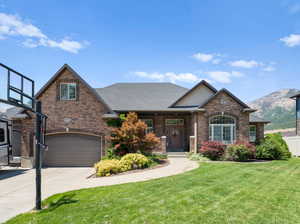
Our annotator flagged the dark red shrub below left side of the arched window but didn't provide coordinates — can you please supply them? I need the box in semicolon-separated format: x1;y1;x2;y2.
200;141;226;160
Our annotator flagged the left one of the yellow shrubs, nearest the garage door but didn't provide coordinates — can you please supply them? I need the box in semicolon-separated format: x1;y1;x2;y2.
94;159;121;177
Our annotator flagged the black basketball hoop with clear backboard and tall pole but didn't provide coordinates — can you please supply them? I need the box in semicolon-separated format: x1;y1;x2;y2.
0;63;47;210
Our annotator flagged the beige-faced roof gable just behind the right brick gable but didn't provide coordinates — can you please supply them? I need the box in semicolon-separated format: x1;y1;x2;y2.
170;80;217;107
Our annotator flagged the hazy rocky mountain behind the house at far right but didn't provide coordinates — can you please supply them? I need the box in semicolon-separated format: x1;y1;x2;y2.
248;89;299;130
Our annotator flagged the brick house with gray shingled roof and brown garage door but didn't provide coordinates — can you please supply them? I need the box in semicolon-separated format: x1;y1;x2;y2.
7;65;267;166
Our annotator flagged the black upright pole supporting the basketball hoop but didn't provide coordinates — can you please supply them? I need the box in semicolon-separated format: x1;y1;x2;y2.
35;101;42;210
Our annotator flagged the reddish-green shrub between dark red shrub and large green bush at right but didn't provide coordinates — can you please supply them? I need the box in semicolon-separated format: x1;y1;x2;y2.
226;142;255;161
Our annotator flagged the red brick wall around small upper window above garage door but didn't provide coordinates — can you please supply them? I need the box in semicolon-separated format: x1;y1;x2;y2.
14;69;109;156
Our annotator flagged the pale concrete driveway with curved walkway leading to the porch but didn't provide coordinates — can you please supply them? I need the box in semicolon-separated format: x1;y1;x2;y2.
0;158;198;223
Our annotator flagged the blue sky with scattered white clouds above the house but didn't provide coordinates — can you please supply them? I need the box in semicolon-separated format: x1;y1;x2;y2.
0;0;300;101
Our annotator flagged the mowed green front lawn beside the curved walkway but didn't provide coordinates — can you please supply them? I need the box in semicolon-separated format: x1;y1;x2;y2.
7;159;300;224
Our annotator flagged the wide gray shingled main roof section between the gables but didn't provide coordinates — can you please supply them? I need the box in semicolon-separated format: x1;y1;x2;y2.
96;83;190;111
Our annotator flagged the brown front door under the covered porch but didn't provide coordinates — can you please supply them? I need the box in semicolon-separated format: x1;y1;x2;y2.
165;119;184;152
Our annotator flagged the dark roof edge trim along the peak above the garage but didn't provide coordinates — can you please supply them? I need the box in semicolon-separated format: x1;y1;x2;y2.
35;64;113;112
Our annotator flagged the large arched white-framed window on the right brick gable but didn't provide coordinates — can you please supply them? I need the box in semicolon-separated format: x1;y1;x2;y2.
209;115;236;144
